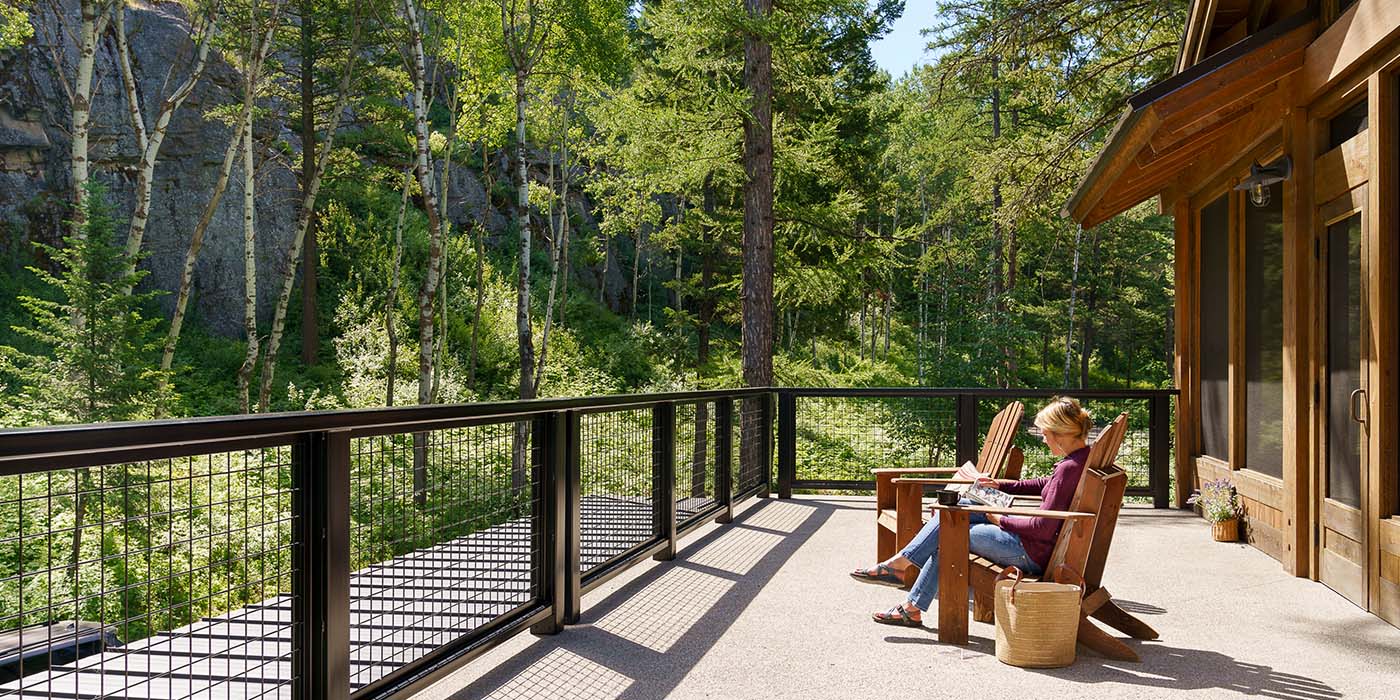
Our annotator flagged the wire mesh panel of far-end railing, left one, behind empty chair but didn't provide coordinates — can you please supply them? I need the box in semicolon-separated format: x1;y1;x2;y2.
797;396;958;480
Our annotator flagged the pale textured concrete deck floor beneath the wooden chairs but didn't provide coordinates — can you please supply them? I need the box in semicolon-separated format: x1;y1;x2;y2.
408;497;1400;700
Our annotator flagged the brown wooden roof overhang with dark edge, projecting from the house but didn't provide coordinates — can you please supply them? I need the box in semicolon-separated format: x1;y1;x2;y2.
1063;13;1317;228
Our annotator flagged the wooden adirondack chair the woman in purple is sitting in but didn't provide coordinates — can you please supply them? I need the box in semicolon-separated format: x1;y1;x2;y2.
969;413;1158;661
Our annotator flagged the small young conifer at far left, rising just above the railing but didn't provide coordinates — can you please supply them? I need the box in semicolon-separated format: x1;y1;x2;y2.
0;183;167;424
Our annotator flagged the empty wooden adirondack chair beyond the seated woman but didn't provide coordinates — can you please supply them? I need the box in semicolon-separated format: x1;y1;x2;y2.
874;400;1025;587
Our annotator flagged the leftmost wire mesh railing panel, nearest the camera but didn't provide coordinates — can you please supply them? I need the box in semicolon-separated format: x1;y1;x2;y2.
0;447;294;699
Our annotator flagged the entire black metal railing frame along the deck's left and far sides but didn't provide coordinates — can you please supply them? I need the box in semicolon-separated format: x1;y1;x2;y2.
0;388;1176;700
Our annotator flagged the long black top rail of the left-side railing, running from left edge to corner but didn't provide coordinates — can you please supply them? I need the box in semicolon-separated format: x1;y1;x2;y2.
0;388;771;470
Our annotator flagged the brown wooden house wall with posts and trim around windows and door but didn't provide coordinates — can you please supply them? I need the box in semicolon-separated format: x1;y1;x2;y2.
1162;0;1400;626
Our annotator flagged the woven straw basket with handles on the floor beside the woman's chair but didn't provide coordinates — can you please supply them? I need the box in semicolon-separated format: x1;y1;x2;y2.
995;567;1084;668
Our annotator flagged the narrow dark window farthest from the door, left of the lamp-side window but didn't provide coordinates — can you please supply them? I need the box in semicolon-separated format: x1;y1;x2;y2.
1200;193;1229;462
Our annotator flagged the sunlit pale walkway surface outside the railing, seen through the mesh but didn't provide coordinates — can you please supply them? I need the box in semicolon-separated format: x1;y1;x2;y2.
0;496;711;700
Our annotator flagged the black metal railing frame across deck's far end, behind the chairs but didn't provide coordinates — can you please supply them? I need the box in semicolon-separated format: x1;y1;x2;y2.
774;388;1177;508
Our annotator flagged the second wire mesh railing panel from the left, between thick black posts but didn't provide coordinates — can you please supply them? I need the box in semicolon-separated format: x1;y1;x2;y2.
350;421;542;689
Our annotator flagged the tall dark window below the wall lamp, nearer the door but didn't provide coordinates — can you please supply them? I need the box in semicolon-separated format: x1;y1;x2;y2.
1240;185;1284;477
